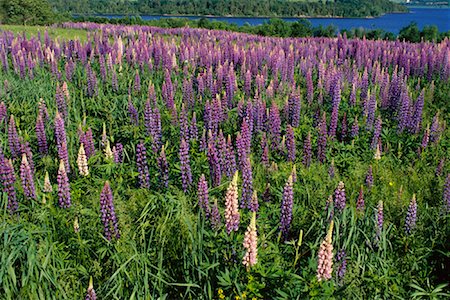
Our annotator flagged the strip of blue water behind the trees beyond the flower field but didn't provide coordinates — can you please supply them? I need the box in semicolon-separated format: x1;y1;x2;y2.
106;8;450;33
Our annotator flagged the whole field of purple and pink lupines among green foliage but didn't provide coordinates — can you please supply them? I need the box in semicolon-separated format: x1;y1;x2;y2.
0;23;450;300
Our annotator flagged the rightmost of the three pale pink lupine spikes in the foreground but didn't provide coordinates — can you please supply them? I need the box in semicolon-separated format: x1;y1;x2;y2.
317;220;334;281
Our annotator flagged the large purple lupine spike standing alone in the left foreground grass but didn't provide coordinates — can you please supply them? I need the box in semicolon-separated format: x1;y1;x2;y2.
100;181;120;241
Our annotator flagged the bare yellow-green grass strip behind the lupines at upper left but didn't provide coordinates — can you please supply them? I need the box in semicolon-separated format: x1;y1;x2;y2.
0;25;86;40
